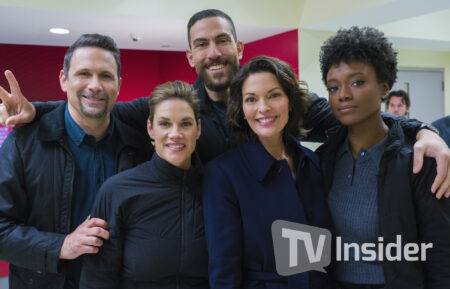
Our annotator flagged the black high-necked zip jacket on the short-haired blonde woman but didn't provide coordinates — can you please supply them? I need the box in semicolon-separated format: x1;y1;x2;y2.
80;153;209;289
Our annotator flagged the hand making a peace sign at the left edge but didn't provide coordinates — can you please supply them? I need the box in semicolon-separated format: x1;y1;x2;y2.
0;70;36;127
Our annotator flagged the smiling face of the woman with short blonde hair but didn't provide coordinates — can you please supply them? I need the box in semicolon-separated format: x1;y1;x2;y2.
147;98;200;170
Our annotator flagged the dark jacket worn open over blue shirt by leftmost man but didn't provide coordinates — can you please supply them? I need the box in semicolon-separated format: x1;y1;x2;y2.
0;102;152;289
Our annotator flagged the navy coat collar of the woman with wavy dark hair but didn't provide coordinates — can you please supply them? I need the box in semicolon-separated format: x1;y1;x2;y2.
238;136;317;182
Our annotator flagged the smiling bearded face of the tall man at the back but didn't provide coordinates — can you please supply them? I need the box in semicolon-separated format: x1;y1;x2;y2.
186;17;244;92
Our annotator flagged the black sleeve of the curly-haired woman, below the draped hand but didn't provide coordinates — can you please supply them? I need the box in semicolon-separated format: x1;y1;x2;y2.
410;157;450;289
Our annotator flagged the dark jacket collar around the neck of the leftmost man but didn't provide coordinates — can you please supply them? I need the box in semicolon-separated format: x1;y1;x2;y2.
38;101;146;148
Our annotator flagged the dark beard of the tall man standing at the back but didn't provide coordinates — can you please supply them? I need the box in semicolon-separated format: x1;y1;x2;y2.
197;57;239;92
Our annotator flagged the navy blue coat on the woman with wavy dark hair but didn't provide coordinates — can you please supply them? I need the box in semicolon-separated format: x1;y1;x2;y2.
203;138;331;289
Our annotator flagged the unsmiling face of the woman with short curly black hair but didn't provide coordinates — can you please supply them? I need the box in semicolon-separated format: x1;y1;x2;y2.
327;61;389;126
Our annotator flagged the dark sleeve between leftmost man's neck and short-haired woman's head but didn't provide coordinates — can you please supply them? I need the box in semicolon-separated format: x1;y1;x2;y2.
111;97;150;135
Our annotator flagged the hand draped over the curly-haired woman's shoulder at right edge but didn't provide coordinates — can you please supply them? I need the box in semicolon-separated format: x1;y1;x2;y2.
414;129;450;199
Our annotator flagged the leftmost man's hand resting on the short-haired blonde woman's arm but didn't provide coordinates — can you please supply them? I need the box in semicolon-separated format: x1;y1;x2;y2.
59;217;109;259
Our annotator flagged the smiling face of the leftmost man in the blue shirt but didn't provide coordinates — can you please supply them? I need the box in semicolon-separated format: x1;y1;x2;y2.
59;47;121;122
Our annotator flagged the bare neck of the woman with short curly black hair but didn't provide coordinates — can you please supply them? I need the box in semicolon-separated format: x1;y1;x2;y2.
348;115;389;159
